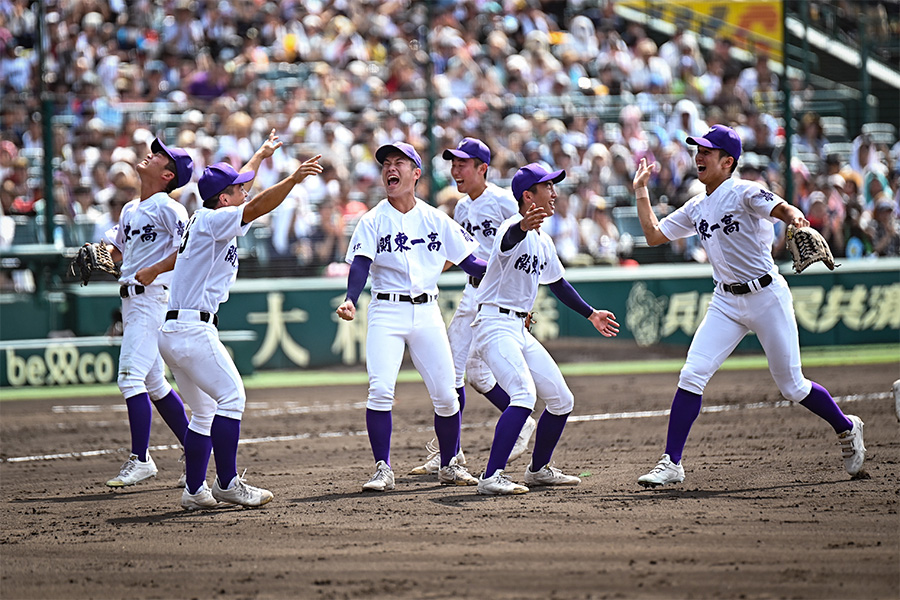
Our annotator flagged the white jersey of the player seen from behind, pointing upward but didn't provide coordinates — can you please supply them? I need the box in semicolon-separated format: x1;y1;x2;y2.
169;206;250;313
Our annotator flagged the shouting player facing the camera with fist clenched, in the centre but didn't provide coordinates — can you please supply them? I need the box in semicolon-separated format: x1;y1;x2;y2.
336;142;488;492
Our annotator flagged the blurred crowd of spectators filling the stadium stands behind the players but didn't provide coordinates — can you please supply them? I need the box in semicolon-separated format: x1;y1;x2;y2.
0;0;900;287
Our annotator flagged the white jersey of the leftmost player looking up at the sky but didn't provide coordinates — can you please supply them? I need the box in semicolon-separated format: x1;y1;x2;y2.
112;192;187;285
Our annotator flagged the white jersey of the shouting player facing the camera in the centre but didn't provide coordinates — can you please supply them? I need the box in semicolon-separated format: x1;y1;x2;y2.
346;198;477;296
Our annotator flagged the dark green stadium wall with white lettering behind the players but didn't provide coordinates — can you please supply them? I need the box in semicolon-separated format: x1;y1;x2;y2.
0;259;900;387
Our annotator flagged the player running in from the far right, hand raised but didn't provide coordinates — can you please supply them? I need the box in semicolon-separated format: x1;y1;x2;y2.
634;125;866;487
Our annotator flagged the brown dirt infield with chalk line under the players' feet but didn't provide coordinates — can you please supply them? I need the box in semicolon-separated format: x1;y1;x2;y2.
0;354;900;599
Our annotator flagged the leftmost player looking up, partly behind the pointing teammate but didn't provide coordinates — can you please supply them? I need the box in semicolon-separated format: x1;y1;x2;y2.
101;139;194;487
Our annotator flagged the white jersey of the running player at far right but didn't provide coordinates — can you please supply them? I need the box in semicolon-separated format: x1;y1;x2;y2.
659;178;783;283
